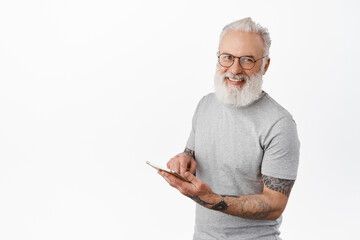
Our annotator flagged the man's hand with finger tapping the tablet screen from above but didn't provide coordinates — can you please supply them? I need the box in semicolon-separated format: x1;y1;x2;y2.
166;148;196;177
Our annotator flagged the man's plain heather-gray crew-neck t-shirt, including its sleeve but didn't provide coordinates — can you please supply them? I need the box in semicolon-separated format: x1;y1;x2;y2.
186;92;300;240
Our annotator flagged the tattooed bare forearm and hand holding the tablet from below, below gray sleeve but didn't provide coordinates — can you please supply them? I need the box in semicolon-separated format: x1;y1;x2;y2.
161;172;294;220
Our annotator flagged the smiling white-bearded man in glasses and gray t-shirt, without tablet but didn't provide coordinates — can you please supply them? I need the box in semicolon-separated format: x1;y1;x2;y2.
159;18;300;239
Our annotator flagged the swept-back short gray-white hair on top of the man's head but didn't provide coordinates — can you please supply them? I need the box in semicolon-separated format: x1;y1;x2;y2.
220;17;271;57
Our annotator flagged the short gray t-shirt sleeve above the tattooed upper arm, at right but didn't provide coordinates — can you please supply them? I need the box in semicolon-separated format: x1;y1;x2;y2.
261;117;300;180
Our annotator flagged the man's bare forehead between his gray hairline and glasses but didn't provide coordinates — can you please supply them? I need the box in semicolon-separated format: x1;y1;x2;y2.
219;30;264;57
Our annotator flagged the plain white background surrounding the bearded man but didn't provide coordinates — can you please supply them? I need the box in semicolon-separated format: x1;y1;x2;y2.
0;0;360;240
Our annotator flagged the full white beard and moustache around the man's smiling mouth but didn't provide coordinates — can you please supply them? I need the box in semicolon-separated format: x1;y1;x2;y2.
214;67;263;107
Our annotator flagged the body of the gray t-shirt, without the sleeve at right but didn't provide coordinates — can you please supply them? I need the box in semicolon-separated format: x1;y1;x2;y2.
187;93;300;239
